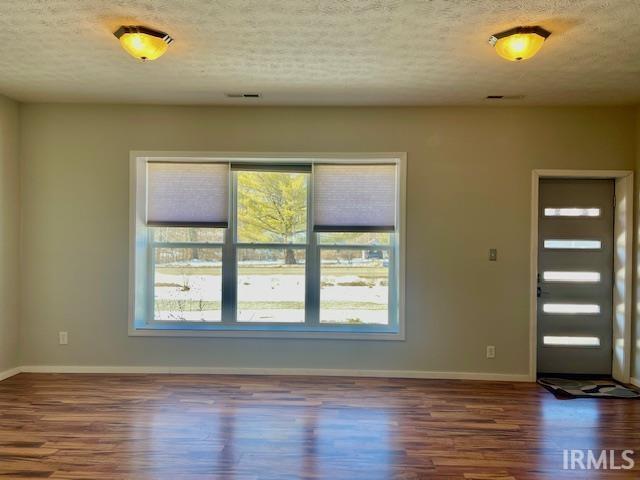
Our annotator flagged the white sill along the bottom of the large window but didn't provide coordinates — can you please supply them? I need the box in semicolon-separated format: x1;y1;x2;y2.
129;324;405;341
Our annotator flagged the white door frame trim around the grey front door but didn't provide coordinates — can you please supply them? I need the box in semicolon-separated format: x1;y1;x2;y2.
529;169;633;383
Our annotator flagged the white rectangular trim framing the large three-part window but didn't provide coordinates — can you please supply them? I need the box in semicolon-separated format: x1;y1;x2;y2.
128;151;407;340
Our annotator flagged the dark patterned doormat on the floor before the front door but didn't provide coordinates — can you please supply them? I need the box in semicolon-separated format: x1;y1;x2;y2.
538;377;640;399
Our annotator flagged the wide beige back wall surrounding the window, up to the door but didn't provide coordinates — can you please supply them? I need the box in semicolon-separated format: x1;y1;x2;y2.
21;105;636;374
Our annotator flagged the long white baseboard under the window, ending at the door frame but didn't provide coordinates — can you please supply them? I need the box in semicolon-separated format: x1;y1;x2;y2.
20;365;531;382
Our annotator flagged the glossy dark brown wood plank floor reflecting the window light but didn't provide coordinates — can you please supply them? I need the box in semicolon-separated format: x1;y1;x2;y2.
0;374;640;480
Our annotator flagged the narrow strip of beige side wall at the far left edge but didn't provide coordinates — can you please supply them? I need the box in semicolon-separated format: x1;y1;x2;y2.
0;95;20;375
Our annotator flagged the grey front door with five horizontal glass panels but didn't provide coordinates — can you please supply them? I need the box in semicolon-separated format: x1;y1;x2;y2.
537;179;614;375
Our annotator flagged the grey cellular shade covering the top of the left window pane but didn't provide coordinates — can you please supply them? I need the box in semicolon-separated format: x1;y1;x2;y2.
147;162;229;227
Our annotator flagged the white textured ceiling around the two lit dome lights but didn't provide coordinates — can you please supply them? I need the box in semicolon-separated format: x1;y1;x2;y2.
0;0;640;105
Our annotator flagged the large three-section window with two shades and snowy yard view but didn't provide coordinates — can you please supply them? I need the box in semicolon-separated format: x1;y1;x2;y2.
130;154;404;339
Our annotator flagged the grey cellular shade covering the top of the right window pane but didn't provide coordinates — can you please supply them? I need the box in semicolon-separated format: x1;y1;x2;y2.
313;164;397;232
